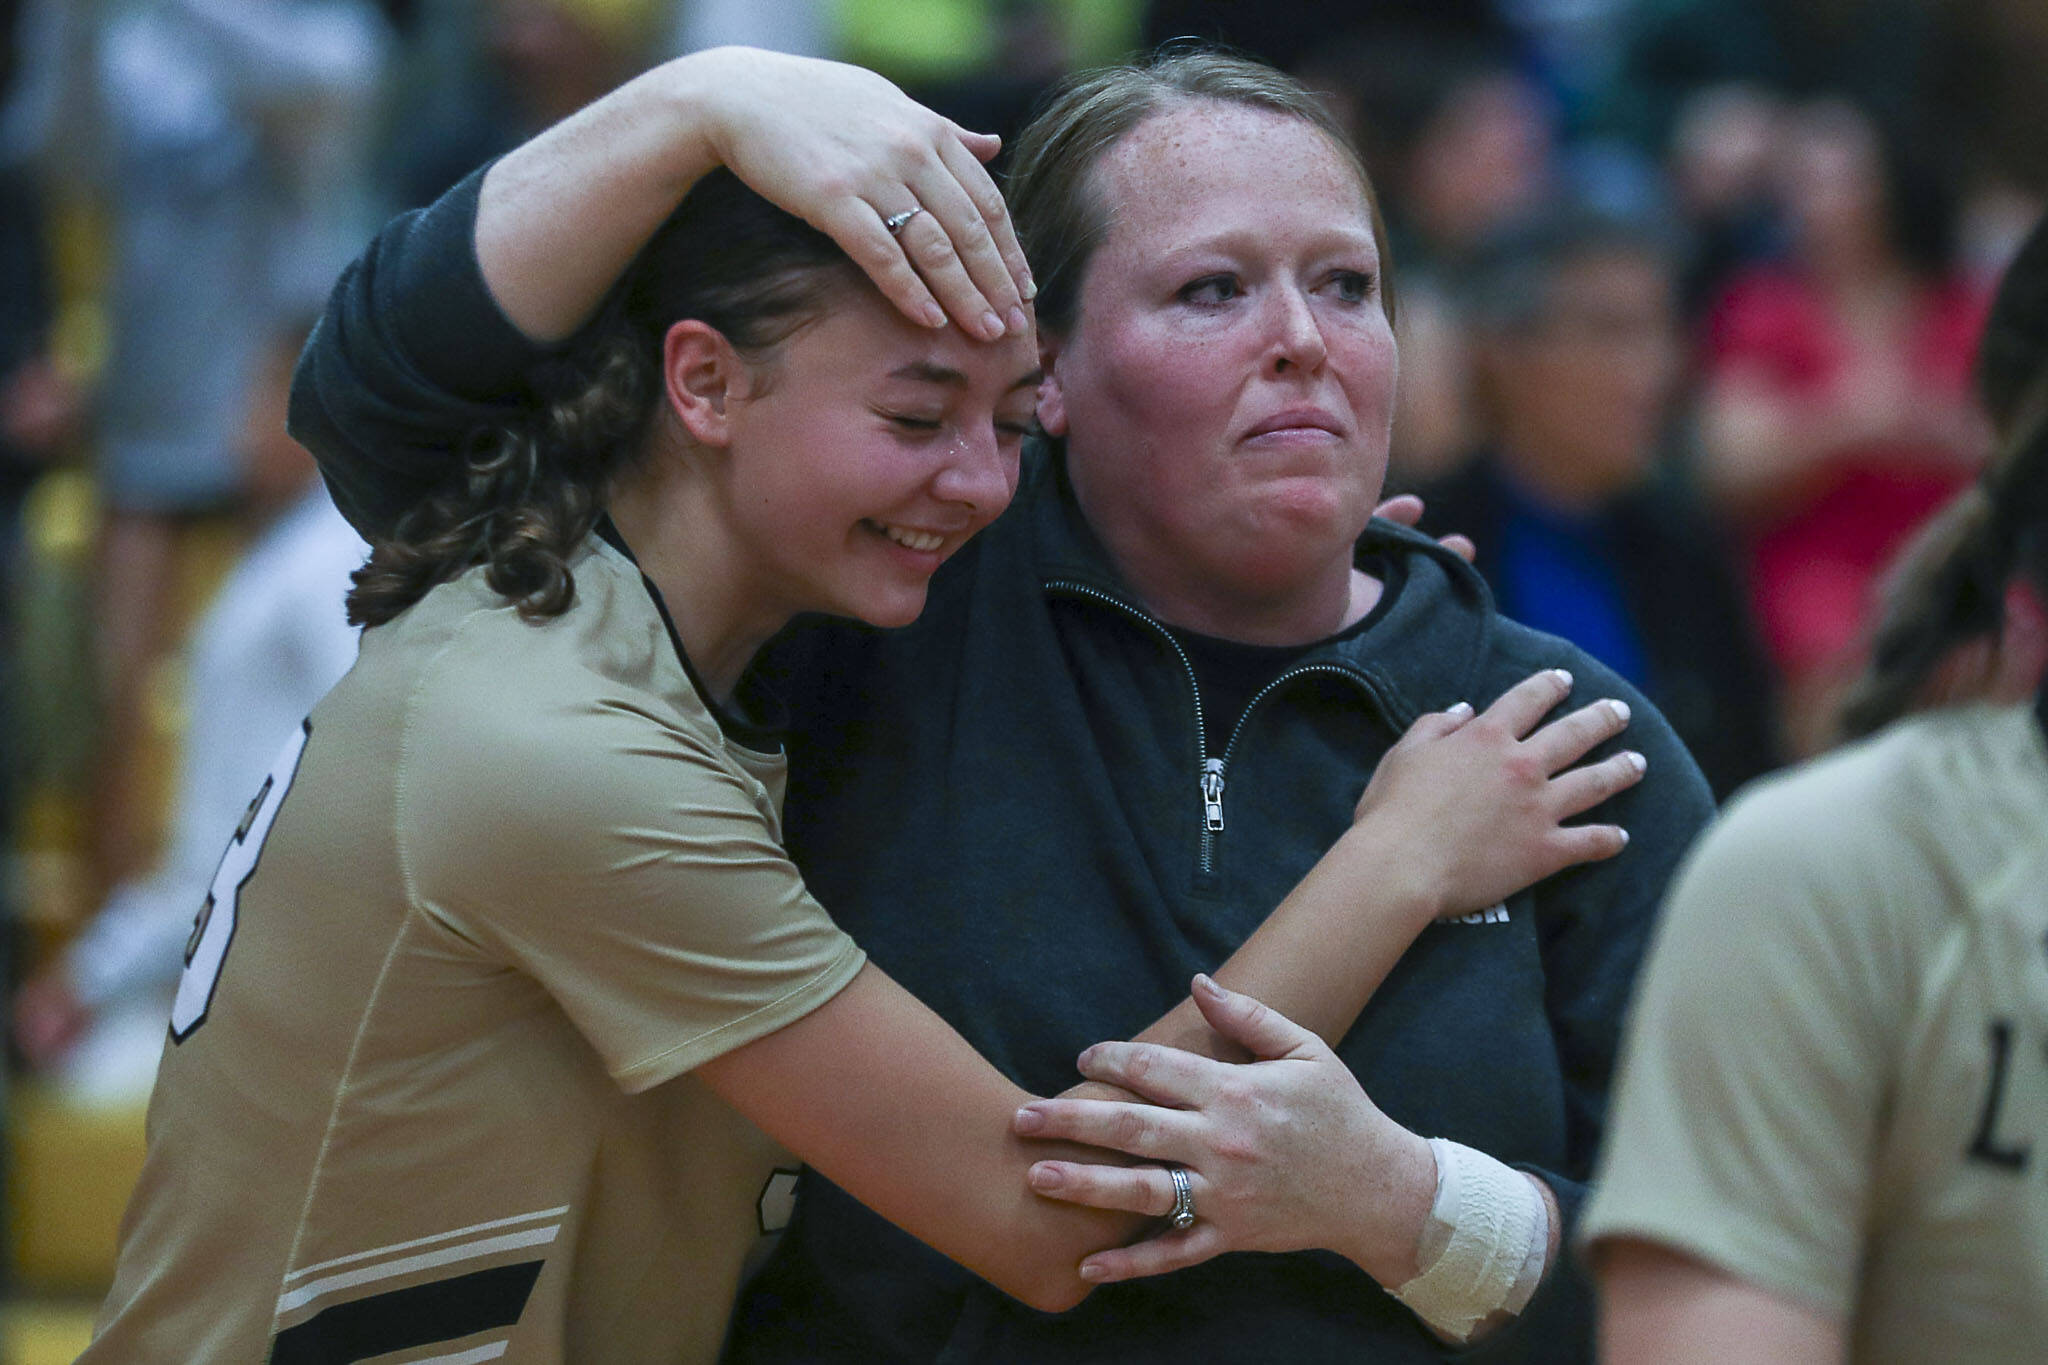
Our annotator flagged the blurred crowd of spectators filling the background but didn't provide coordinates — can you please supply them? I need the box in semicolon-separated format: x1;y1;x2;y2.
0;0;2048;1162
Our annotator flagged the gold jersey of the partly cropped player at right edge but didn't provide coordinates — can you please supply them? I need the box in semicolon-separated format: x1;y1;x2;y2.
1581;706;2048;1361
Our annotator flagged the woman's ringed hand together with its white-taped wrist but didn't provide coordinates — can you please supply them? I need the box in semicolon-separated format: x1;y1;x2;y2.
1016;976;1563;1345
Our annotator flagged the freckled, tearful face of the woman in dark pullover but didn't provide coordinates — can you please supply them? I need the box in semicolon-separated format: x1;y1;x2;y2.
1038;102;1395;639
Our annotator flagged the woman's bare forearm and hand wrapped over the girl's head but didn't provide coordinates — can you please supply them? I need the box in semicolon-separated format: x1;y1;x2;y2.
477;47;1032;342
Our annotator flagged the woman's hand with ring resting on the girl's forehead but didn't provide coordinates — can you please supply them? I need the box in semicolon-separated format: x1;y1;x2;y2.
700;47;1034;340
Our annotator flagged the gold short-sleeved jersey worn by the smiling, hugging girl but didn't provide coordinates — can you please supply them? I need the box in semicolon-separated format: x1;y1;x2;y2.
82;536;862;1365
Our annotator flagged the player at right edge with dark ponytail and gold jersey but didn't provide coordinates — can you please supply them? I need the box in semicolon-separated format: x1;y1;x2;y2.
1587;208;2048;1365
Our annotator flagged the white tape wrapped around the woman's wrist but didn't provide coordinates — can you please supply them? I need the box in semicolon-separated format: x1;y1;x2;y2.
1393;1138;1550;1342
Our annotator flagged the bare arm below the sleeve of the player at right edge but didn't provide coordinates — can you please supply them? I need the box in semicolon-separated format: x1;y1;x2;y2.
1595;1238;1847;1365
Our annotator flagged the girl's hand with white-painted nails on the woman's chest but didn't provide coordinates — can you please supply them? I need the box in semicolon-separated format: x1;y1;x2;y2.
1358;669;1645;917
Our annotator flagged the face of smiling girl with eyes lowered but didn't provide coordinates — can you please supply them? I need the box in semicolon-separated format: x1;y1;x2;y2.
721;284;1038;626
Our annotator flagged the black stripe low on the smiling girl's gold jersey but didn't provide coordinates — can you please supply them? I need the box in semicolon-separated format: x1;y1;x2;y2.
270;1261;543;1365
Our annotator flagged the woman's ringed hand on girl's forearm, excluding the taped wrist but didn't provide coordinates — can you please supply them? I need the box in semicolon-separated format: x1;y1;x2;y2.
1014;976;1436;1285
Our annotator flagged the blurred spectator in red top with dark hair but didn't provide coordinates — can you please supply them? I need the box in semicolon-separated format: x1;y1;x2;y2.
1700;100;1987;753
